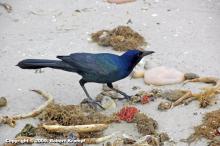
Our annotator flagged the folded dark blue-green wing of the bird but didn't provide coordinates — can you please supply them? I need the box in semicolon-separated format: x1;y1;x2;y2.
57;53;120;75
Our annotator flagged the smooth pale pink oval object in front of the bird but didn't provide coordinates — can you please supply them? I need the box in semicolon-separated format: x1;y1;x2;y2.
144;66;184;85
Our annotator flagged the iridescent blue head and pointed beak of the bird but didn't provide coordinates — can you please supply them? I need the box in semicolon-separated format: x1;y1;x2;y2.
121;50;154;69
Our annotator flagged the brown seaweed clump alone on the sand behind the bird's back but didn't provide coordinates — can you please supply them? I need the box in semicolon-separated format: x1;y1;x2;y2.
91;26;145;51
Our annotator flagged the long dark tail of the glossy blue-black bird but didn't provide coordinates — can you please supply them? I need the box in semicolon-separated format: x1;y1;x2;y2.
17;59;74;71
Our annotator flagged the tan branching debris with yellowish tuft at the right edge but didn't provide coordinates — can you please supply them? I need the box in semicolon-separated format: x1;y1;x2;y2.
153;77;220;110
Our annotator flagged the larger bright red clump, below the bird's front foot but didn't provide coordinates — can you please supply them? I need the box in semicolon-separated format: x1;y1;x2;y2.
117;107;139;122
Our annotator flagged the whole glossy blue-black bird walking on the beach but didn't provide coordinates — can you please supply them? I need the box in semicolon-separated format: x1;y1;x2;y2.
17;50;154;108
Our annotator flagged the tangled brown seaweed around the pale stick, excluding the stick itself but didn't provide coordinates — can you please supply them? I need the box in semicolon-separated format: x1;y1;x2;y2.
37;104;118;138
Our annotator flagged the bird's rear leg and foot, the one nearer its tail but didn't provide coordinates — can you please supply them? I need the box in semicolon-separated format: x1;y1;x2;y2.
79;79;105;109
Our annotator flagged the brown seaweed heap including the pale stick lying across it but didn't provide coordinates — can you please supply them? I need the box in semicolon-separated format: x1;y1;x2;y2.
37;103;119;140
